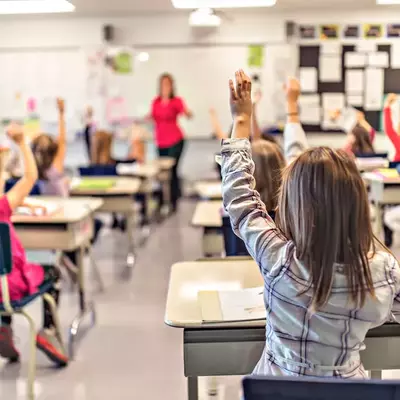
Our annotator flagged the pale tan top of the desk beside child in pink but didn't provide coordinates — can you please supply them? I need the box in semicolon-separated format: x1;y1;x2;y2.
12;196;103;224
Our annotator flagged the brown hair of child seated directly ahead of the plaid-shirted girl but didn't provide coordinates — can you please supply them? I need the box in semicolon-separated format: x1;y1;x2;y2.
251;139;285;211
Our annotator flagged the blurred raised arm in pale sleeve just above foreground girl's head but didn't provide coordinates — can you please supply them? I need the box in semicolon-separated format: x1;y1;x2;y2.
283;78;308;163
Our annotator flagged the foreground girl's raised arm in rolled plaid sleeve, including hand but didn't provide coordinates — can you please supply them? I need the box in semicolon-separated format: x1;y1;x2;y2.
221;71;286;273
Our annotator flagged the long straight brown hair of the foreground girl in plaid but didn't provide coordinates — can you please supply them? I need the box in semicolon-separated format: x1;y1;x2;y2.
276;147;376;311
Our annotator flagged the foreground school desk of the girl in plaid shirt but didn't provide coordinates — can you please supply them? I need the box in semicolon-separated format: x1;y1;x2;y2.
165;258;400;400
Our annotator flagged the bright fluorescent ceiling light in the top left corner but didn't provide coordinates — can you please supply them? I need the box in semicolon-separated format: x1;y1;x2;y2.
0;0;75;14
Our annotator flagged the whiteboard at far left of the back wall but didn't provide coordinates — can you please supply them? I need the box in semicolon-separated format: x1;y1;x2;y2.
0;48;85;136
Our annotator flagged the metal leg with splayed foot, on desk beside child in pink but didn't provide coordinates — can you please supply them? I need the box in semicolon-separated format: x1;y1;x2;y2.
68;247;96;359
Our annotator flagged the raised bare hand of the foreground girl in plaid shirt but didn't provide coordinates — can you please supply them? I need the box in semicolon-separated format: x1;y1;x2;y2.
229;69;253;119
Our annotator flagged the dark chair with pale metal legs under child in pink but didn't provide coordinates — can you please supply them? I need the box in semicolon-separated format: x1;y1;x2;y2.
0;222;65;399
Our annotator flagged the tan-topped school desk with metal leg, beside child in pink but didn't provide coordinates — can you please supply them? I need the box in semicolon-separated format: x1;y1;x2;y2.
12;196;103;357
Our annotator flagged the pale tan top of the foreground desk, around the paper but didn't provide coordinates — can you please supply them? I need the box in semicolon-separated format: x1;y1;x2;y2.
165;258;265;328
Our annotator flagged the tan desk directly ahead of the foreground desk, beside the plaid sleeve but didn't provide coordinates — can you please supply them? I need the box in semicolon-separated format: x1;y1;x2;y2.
192;200;224;256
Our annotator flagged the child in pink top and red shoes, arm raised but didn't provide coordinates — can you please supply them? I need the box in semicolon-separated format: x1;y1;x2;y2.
0;125;68;367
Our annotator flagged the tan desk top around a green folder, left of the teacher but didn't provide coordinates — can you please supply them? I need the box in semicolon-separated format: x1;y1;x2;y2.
71;176;141;197
